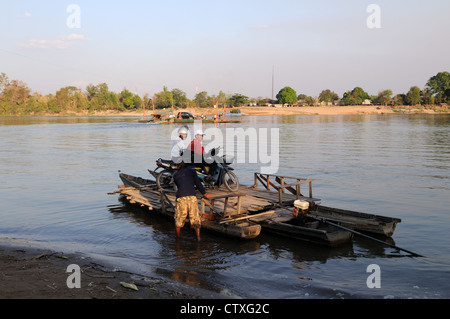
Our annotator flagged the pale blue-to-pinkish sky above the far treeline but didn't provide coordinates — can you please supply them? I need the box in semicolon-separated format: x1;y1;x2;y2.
0;0;450;99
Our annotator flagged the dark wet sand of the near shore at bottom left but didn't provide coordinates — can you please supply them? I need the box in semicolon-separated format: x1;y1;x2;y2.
0;240;220;299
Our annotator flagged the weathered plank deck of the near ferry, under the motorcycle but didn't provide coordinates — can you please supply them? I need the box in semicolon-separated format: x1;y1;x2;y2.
114;173;320;239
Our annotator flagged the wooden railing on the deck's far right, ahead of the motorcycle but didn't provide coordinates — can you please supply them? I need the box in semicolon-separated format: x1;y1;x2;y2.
252;173;315;204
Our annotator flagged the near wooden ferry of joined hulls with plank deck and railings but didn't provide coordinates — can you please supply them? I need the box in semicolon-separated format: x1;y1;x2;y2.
110;173;401;247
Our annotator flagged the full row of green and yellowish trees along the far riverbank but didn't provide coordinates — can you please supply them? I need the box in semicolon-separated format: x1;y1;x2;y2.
0;72;450;116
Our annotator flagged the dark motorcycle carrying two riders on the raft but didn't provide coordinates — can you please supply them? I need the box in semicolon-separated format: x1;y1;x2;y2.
149;148;239;192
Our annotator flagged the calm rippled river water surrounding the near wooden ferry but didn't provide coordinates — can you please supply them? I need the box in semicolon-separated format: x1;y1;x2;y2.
0;114;450;299
